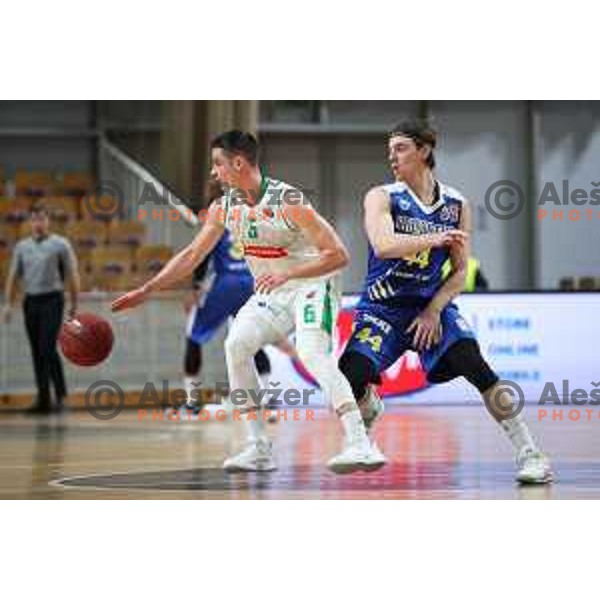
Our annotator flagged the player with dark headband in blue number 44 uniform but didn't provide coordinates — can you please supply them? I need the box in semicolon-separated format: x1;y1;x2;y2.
340;120;552;483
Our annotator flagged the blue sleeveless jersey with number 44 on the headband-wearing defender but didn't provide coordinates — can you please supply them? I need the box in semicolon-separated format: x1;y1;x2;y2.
362;181;465;304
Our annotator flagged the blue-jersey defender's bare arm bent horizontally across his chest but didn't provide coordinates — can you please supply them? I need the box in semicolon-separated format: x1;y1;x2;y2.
364;187;467;259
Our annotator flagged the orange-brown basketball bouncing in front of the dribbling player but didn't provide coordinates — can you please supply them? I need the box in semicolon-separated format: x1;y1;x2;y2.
58;313;114;367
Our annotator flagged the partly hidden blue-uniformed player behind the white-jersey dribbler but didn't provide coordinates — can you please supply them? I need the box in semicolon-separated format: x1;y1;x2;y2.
184;180;271;411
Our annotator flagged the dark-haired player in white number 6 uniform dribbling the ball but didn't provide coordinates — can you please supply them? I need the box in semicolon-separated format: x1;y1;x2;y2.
112;130;385;473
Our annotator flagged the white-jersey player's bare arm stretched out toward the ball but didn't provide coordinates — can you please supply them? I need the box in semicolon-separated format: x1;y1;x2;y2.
111;203;224;312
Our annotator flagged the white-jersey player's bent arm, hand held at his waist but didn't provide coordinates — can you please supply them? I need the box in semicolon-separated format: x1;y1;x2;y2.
254;197;350;292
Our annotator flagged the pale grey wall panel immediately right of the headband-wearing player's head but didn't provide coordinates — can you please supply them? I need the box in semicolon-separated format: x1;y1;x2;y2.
431;102;530;289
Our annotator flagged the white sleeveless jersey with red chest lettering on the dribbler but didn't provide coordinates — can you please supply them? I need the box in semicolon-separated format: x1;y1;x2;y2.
224;178;319;277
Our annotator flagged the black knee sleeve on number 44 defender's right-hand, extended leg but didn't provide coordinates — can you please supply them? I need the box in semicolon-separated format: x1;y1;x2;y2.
427;339;499;393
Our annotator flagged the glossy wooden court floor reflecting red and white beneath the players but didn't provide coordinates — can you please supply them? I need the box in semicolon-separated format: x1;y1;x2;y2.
0;406;600;499
